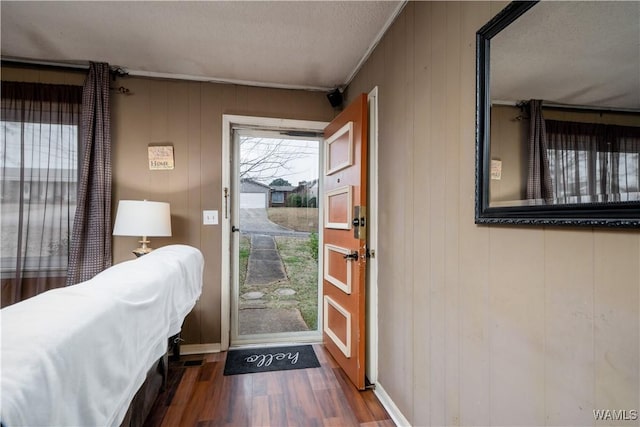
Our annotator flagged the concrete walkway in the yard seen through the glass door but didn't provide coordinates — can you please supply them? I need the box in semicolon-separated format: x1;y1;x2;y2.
238;234;309;335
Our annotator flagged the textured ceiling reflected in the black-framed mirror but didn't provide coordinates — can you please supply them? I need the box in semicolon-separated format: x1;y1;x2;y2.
490;1;640;109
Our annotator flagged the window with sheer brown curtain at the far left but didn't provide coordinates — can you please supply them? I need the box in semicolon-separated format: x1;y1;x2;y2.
0;81;82;307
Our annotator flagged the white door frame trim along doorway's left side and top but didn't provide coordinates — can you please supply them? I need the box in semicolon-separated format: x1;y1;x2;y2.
220;114;329;351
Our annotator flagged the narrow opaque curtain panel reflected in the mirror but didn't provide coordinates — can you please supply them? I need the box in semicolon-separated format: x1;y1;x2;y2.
527;99;553;200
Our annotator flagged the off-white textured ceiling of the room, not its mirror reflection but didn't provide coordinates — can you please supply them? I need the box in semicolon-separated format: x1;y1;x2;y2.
0;1;404;90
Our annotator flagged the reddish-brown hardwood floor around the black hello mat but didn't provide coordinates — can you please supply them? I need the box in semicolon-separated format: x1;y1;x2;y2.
145;344;395;427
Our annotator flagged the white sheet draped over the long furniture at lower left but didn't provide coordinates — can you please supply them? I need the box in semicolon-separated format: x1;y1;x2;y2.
0;245;204;427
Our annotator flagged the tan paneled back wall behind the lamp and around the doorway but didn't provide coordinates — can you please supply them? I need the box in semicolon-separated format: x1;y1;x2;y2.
2;67;336;344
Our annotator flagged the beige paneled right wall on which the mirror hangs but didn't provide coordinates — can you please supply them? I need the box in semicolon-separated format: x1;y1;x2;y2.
348;2;640;426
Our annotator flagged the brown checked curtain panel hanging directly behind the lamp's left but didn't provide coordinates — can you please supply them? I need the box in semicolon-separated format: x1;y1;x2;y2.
67;63;112;285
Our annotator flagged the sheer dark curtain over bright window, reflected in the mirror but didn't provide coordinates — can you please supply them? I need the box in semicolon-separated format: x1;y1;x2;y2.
546;120;640;202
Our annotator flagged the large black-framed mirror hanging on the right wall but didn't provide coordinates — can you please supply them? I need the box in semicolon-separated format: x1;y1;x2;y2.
476;2;640;227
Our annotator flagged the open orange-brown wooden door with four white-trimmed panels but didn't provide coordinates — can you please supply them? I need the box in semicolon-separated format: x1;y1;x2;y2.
322;94;368;390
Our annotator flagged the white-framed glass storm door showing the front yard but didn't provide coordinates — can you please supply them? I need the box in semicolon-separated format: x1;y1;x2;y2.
228;117;322;347
